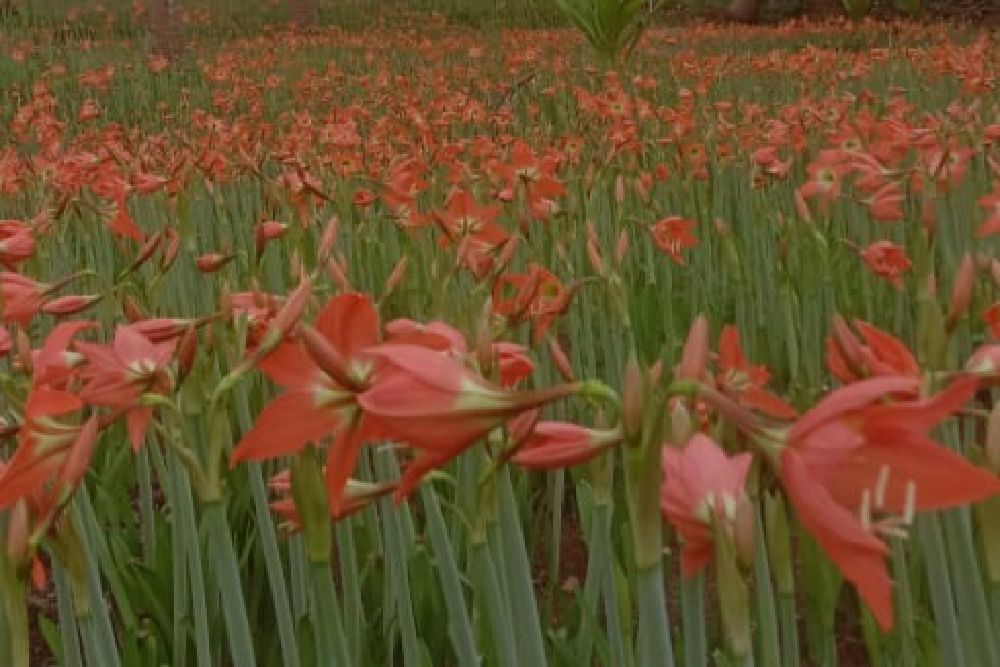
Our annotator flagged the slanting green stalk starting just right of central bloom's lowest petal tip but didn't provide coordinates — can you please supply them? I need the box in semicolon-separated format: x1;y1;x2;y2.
420;484;479;667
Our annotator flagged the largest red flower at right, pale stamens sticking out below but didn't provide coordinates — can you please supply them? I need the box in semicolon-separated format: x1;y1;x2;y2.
771;377;1000;630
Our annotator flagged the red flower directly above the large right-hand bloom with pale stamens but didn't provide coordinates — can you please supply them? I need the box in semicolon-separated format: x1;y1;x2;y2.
826;315;920;384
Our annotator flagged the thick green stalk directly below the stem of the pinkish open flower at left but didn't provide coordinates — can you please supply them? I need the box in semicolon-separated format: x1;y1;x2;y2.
201;501;257;665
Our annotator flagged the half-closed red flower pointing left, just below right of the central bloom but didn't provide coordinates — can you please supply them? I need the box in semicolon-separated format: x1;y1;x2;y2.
513;422;624;470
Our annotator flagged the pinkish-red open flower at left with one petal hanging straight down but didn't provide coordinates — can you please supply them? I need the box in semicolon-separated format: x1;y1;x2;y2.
76;326;176;449
